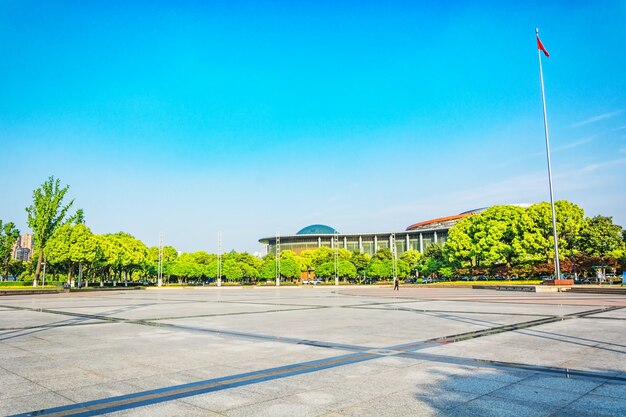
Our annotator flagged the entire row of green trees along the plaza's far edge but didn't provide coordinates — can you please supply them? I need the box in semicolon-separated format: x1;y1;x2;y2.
0;177;626;285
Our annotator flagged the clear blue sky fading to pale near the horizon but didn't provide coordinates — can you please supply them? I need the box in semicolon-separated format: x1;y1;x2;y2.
0;0;626;252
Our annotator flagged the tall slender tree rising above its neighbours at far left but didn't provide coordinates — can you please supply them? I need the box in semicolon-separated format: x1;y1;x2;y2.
26;177;79;286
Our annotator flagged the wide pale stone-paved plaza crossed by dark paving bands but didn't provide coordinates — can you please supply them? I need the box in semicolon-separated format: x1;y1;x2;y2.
0;287;626;417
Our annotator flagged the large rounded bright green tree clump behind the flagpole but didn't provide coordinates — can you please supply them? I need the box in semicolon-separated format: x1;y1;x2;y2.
441;201;626;276
